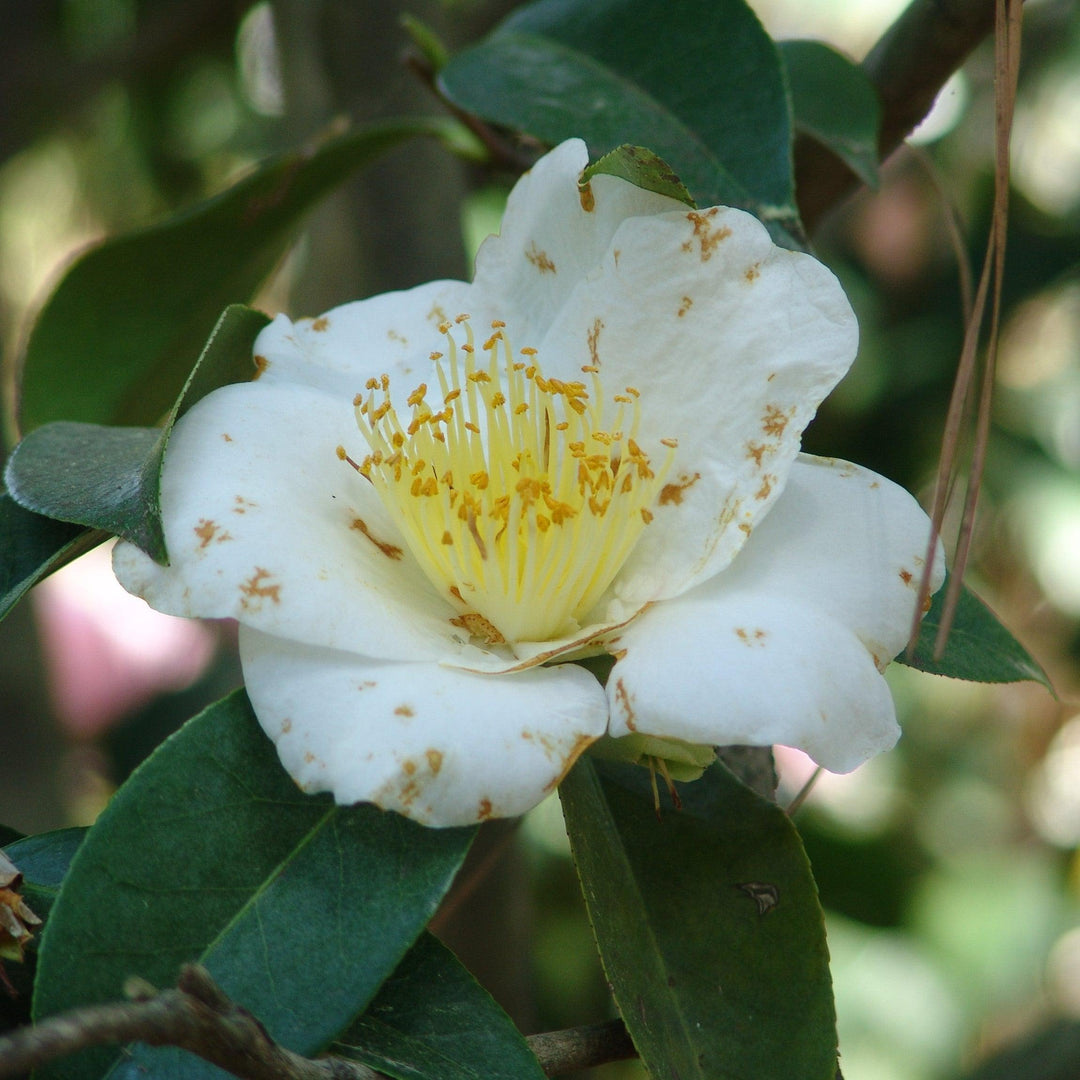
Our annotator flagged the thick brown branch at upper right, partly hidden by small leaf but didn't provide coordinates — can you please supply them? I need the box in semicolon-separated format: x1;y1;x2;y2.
795;0;994;231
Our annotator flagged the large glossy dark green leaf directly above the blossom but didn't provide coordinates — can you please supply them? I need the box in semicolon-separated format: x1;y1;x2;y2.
440;0;798;231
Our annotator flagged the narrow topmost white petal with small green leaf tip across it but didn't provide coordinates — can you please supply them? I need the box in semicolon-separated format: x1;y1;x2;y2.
470;139;681;339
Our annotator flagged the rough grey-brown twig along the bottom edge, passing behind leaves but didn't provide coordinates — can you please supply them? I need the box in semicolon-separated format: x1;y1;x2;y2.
0;964;636;1080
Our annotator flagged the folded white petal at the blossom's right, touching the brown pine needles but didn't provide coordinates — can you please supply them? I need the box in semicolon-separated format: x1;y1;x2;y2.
608;457;942;772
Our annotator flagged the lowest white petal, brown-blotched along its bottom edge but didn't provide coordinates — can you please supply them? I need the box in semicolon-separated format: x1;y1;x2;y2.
240;627;607;825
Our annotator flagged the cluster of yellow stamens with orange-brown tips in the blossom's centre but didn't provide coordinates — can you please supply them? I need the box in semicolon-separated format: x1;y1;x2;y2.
338;315;676;643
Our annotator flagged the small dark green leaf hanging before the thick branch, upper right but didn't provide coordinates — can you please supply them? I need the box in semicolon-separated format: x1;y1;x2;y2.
779;41;881;188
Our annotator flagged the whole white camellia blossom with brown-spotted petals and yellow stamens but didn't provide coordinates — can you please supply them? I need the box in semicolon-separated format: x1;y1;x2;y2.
113;140;940;825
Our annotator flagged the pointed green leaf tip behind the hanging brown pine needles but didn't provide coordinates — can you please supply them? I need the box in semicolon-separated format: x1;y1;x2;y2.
896;582;1053;692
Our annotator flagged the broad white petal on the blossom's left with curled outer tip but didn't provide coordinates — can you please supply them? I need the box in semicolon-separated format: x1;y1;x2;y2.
113;381;496;660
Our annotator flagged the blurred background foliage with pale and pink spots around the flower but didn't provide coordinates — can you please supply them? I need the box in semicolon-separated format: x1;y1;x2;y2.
0;0;1080;1080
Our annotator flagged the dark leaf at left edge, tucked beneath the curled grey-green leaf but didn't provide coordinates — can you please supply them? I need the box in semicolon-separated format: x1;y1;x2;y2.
0;491;91;619
